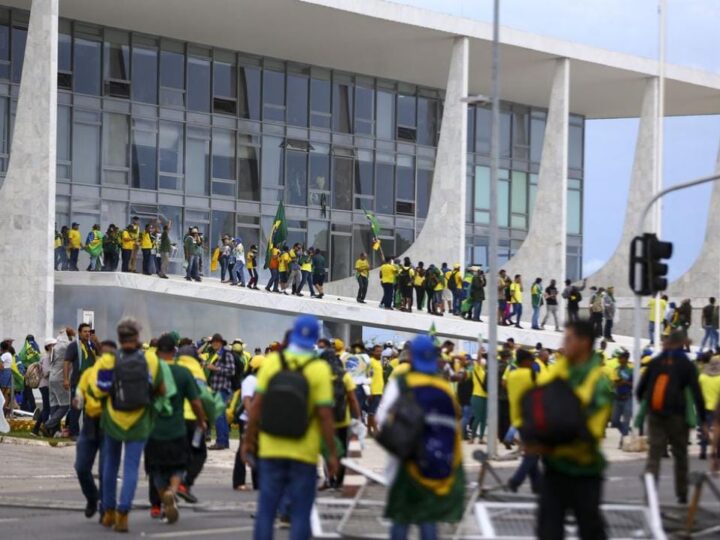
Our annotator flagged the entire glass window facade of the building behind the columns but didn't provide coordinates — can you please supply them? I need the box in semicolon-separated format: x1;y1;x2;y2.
0;8;583;279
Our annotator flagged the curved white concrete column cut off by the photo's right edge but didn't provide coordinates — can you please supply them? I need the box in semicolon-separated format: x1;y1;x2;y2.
668;140;720;296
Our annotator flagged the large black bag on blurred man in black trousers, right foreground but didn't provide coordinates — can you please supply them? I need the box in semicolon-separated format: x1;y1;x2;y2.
520;372;592;448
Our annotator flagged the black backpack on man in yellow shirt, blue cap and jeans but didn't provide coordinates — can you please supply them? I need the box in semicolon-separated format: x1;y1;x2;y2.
260;353;317;439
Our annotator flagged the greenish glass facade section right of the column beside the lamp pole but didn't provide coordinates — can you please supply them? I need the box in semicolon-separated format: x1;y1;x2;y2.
465;103;585;280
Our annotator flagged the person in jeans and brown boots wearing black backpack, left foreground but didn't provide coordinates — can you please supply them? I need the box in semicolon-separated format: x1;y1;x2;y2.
90;319;165;532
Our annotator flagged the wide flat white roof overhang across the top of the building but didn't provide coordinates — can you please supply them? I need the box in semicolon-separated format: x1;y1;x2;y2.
7;0;720;118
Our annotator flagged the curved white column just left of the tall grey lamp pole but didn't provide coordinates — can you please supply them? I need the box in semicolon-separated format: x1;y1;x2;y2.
326;37;470;300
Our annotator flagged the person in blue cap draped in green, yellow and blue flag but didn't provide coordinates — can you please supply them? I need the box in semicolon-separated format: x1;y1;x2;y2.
378;335;465;540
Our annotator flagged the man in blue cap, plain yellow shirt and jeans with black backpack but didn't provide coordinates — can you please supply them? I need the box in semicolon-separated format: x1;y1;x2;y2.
242;315;338;540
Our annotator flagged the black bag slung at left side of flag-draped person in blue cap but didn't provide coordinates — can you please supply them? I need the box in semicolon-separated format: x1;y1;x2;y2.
375;377;425;461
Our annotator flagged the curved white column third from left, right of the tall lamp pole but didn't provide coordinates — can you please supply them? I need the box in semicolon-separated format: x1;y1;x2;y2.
504;58;570;319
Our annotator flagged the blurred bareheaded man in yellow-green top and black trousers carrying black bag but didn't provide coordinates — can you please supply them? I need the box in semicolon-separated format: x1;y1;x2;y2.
520;320;612;540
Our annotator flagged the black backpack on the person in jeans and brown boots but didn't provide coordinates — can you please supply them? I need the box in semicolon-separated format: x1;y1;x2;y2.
110;350;152;411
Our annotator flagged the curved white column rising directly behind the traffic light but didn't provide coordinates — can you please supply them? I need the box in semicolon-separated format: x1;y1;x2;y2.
588;77;660;297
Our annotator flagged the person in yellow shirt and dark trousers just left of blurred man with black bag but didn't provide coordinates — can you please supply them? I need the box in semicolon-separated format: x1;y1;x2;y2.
507;349;540;493
